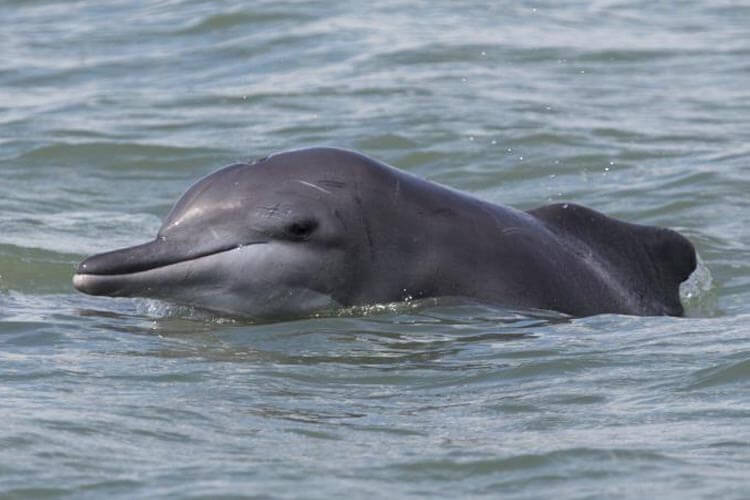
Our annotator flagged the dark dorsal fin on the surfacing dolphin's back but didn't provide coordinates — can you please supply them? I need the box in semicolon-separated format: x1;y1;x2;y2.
529;203;696;316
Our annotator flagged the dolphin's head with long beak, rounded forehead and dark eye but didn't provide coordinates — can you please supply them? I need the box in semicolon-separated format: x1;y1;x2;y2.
73;149;388;318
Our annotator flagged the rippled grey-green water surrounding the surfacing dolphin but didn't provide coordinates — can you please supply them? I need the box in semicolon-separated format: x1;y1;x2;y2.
0;0;750;499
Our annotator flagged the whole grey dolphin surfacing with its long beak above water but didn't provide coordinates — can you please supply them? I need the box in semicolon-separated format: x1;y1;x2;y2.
73;148;696;319
